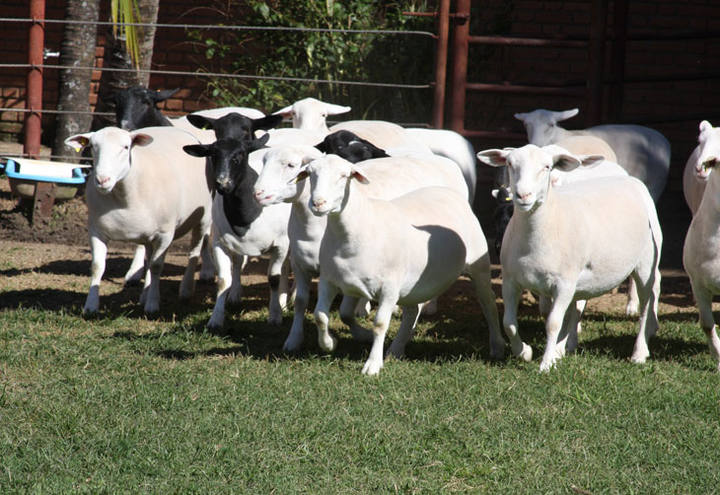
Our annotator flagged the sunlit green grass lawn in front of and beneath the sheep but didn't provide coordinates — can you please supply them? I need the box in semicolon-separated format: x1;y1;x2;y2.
0;289;720;494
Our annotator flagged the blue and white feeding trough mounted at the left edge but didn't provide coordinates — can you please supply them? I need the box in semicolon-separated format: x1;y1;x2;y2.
5;158;89;199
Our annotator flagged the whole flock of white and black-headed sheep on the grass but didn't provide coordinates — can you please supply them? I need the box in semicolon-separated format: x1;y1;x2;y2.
54;87;720;375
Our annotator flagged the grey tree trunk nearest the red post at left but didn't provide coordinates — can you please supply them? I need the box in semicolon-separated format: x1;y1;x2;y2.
52;0;100;162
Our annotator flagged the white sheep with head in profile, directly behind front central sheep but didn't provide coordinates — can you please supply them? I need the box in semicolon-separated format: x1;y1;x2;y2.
255;146;467;352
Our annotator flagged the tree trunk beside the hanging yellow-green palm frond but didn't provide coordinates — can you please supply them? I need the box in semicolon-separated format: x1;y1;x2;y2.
92;0;160;129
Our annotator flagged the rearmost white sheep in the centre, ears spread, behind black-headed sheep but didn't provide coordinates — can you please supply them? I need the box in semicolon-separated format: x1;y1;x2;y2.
275;98;477;202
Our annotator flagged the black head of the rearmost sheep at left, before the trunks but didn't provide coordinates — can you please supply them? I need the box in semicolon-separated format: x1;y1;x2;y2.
115;86;176;131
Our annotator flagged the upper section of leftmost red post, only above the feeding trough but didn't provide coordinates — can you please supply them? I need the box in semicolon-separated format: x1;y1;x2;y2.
23;0;45;158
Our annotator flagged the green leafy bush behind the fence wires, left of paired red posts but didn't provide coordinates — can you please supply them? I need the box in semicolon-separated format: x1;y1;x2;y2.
190;0;434;120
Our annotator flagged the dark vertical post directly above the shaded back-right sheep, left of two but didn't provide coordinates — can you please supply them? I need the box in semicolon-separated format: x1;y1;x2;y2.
585;0;608;127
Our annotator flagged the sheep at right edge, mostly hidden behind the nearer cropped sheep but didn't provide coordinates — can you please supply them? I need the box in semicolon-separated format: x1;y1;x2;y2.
683;120;720;216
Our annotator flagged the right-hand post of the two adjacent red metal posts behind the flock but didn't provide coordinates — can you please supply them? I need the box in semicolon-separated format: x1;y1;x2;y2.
450;0;470;133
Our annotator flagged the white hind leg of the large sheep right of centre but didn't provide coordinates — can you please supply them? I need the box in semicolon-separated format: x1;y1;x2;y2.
630;257;660;364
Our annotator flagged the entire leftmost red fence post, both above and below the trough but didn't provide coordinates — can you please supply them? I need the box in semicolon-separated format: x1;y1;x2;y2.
23;0;55;222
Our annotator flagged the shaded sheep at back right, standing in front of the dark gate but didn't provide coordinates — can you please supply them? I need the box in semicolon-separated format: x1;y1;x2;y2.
515;108;670;203
